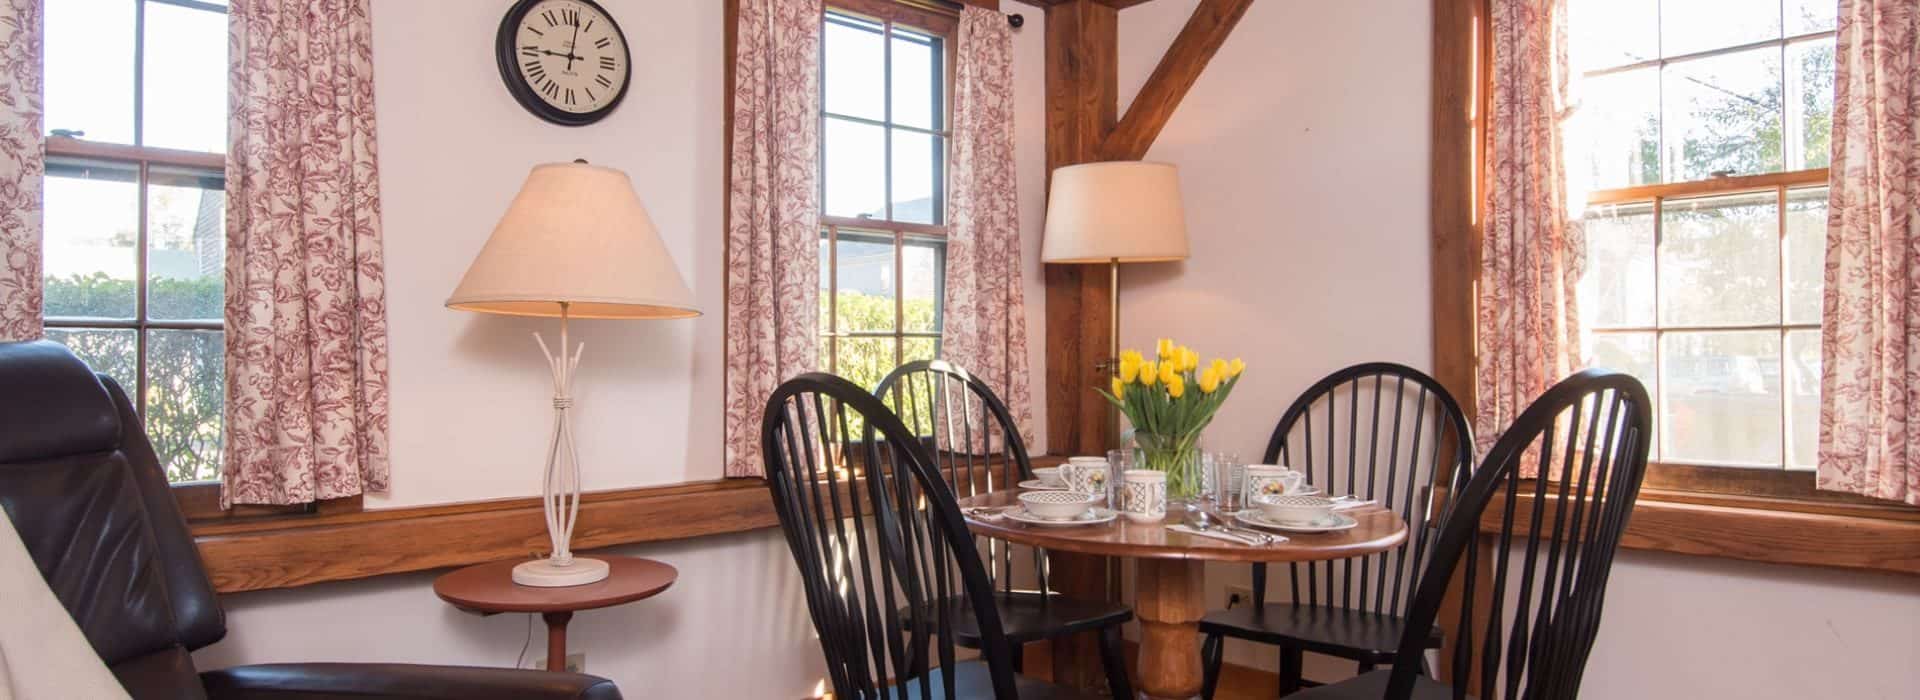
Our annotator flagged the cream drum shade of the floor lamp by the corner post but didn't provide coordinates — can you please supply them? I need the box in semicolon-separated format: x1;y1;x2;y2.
1041;161;1187;263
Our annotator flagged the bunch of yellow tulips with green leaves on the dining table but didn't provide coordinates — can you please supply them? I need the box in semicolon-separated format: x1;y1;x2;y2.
1094;338;1246;501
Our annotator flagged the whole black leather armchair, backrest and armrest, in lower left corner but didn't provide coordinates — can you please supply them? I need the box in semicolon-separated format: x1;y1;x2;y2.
0;341;620;700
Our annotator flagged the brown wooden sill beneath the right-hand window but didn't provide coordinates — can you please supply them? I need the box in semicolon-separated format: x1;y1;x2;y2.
1480;489;1920;575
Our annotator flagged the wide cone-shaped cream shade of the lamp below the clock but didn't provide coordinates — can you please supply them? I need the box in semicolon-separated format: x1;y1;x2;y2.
447;163;701;318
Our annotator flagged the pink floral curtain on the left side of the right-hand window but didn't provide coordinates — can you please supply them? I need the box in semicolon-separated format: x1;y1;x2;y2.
1473;0;1586;453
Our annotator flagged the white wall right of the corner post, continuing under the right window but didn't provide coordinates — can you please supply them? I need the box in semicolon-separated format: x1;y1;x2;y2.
1119;0;1920;700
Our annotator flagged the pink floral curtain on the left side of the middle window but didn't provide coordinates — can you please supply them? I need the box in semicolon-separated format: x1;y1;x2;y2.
726;0;822;478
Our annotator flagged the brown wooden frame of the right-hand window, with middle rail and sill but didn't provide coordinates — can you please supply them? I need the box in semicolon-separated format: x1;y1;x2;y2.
1428;0;1920;573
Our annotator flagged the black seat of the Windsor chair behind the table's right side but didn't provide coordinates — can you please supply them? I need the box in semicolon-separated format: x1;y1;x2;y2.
1200;602;1440;664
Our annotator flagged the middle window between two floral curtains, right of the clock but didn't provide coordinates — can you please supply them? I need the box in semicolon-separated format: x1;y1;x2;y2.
820;2;952;387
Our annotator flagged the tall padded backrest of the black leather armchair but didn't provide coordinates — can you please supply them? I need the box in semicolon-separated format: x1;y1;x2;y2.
0;341;227;667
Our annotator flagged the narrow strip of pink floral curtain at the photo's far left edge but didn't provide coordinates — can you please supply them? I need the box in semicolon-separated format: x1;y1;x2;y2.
0;0;46;341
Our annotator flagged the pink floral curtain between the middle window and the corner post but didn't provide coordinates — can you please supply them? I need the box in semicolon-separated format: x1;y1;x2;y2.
941;6;1033;437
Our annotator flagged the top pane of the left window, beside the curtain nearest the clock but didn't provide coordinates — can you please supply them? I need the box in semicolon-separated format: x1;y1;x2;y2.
140;2;227;153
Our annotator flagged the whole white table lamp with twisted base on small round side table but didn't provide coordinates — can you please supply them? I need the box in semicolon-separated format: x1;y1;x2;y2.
447;161;701;587
